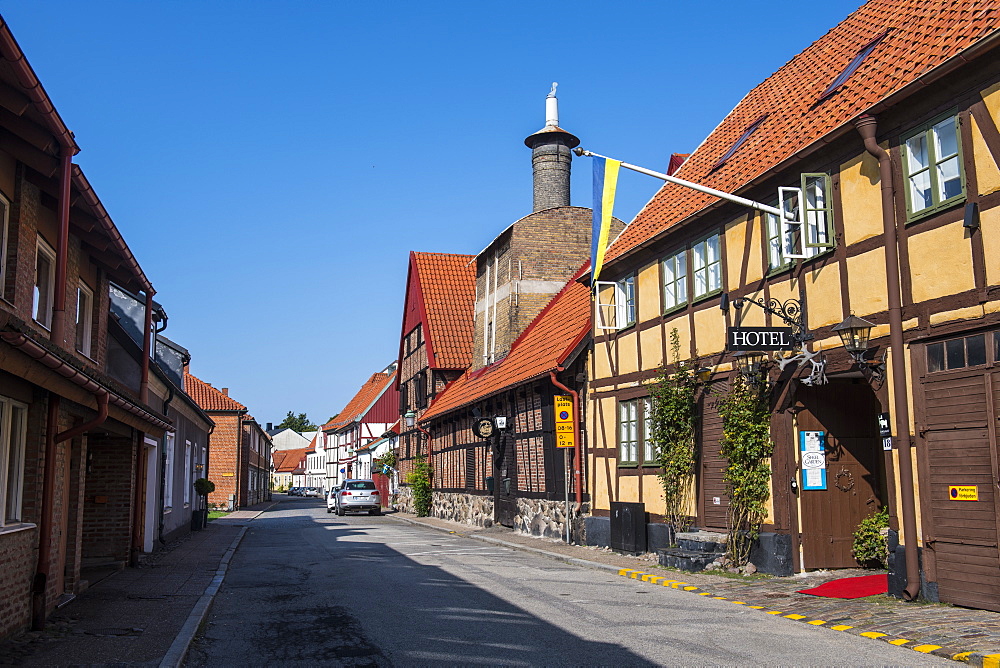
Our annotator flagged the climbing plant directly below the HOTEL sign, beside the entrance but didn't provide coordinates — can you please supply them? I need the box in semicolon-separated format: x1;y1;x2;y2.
717;374;774;566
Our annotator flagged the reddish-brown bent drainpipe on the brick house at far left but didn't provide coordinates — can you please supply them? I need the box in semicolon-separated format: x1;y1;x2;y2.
31;389;108;631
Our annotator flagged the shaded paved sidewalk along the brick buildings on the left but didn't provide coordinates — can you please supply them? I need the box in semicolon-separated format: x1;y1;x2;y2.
0;502;272;666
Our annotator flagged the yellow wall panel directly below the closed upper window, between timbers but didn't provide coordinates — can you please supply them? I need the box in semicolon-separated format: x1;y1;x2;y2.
908;222;976;302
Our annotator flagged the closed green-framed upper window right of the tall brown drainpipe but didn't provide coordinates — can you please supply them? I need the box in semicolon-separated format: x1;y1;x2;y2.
903;116;965;219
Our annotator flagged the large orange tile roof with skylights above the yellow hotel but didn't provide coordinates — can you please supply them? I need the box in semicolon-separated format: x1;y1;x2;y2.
607;0;1000;262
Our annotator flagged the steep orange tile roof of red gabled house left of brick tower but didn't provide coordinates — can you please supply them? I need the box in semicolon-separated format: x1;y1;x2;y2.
413;253;476;369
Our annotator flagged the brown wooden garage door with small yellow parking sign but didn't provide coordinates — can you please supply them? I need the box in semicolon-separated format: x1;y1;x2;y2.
917;333;1000;610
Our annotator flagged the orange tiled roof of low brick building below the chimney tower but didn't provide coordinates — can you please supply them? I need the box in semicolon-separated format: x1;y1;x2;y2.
420;261;591;422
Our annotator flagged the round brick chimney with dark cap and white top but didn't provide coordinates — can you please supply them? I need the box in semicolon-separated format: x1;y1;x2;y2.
524;82;580;212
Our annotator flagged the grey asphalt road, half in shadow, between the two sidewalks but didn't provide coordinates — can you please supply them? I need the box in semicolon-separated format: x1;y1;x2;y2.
186;499;954;666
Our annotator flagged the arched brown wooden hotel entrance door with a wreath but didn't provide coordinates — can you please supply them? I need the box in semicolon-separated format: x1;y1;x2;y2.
795;379;882;569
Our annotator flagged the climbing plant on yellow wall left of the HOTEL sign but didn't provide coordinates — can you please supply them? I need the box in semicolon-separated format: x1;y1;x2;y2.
649;329;698;532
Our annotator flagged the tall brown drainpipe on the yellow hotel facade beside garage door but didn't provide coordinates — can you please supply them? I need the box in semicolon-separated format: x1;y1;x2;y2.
854;115;920;601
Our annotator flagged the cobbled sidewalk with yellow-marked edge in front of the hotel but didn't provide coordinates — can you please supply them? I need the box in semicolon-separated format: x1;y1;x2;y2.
390;513;1000;668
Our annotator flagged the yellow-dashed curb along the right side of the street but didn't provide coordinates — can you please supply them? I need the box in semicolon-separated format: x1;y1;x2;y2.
393;517;1000;668
